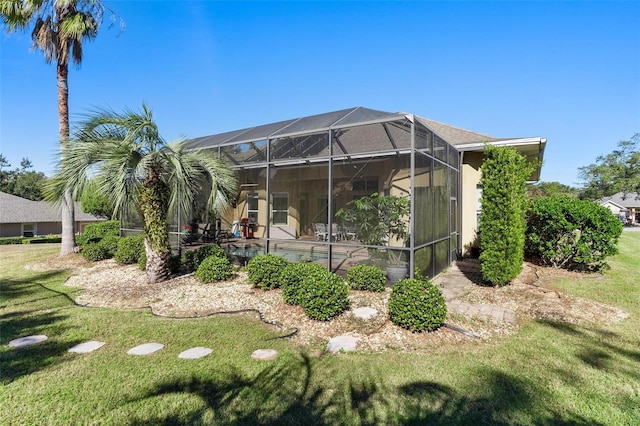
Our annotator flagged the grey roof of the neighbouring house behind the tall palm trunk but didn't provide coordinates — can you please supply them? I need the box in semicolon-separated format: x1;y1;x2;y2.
0;192;104;223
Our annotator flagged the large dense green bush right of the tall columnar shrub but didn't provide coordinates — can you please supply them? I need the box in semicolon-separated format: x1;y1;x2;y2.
525;197;622;271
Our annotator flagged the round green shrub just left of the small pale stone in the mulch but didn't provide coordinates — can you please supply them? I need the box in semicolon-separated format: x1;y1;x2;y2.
298;265;350;321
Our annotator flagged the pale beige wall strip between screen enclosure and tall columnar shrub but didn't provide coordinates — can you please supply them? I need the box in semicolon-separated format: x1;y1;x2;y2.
460;152;484;255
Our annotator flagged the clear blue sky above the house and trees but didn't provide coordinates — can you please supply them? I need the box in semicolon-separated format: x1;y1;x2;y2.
0;1;640;185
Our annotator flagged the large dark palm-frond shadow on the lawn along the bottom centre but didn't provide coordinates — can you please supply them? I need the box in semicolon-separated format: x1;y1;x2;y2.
124;355;599;426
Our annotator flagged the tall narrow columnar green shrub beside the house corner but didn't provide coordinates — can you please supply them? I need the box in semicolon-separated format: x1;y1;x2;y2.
478;145;535;286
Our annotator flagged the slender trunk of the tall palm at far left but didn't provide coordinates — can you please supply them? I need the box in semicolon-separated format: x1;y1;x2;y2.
56;61;76;256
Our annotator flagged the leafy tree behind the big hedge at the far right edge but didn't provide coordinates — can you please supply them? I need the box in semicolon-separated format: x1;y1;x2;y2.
578;133;640;200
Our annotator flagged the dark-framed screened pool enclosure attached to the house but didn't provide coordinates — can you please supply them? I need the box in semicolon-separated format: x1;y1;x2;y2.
172;107;460;277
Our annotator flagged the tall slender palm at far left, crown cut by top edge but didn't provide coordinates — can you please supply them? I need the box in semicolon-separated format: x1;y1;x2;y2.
0;0;111;256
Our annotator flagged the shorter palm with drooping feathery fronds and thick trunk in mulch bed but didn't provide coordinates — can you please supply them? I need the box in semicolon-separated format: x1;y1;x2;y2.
49;104;237;283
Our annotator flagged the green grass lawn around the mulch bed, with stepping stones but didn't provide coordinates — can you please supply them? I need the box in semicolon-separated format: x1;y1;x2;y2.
0;233;640;425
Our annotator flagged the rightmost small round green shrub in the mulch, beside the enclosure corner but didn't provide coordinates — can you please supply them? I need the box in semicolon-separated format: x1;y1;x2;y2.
388;278;447;332
